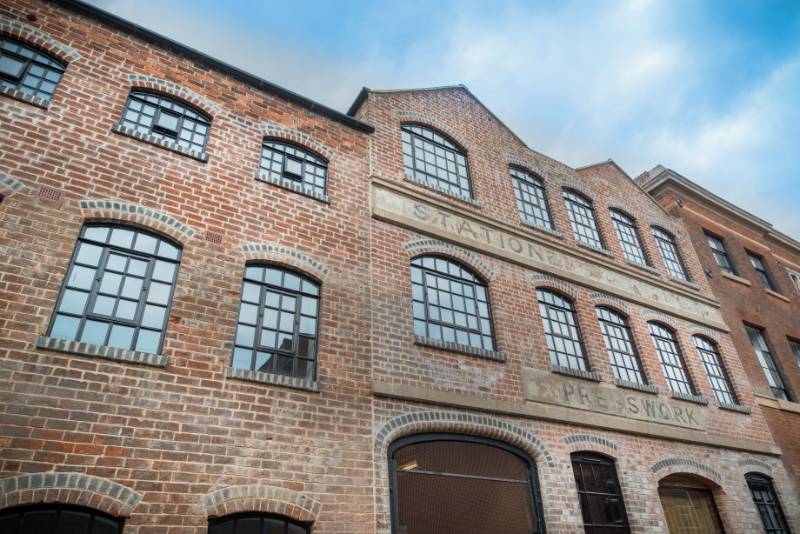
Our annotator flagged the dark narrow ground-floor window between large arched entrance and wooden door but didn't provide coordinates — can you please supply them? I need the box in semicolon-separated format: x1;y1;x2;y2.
571;452;630;534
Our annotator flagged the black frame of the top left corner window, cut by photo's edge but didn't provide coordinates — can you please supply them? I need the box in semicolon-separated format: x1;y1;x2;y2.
0;35;67;103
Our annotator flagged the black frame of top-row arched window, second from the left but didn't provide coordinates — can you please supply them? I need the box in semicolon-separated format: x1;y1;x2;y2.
119;88;212;154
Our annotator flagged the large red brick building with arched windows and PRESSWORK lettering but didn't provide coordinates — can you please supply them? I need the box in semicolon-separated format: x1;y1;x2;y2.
0;0;800;534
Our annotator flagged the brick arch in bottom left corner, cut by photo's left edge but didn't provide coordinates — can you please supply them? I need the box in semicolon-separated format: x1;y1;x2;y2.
0;472;142;517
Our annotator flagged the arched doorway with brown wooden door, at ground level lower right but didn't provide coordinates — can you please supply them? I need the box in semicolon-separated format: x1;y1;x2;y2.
658;473;725;534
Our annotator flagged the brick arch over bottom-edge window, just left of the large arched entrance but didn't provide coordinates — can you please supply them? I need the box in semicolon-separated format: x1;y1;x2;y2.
203;484;322;522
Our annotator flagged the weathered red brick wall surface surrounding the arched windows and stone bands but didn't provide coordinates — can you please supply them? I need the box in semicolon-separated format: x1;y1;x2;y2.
0;0;800;534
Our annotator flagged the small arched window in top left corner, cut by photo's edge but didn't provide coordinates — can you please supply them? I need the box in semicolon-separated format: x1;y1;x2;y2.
0;36;66;102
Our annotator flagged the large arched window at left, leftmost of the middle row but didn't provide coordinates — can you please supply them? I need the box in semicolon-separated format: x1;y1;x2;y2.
49;224;181;354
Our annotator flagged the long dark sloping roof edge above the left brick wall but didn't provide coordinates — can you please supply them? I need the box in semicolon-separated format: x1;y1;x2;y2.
48;0;375;133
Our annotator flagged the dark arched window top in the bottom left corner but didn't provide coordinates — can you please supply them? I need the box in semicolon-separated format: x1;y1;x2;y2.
0;504;123;534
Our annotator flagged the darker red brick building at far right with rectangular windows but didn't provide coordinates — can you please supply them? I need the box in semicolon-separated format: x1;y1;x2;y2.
637;166;800;496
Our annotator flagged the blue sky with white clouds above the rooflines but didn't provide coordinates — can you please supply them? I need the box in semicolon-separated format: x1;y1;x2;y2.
92;0;800;239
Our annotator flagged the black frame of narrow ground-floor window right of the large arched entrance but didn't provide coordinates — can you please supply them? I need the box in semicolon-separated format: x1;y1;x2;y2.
570;451;631;534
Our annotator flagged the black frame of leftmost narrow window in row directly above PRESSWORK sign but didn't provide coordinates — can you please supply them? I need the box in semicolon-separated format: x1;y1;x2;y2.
536;287;592;372
